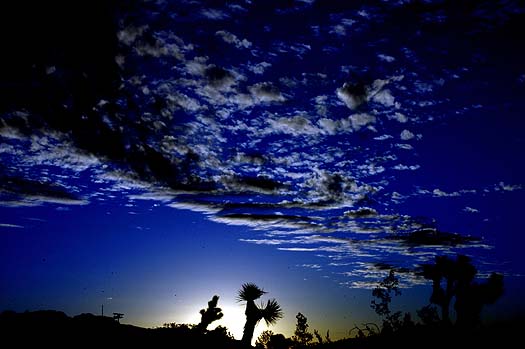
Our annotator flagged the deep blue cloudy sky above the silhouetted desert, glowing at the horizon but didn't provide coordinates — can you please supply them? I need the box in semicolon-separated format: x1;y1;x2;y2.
0;0;525;339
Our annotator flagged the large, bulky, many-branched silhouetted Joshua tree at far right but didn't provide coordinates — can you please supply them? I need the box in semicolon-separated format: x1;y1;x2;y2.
423;255;503;326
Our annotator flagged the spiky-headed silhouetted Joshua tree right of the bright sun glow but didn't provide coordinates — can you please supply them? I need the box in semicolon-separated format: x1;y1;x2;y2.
237;283;283;346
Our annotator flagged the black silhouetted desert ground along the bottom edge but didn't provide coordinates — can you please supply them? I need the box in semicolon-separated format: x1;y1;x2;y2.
0;310;525;349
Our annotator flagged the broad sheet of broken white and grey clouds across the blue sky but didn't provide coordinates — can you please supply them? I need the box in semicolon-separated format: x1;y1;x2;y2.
0;0;523;287
